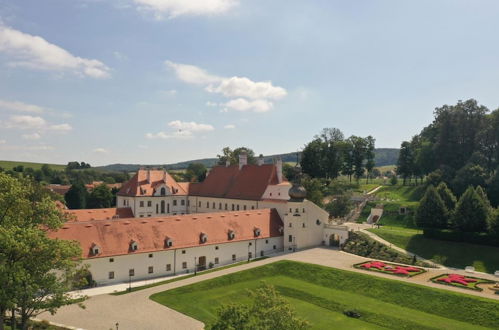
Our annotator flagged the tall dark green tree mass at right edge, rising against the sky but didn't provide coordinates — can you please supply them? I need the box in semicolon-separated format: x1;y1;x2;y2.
397;99;499;206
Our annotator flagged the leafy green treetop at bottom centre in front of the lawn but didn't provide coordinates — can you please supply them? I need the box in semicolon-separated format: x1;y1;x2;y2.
208;283;310;330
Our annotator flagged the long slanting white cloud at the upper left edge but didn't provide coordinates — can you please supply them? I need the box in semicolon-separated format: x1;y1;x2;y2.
0;25;110;78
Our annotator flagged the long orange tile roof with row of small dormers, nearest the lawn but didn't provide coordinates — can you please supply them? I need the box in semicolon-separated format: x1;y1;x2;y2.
48;209;283;258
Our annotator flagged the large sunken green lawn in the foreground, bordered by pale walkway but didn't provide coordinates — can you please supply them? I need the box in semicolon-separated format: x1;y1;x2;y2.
151;261;499;329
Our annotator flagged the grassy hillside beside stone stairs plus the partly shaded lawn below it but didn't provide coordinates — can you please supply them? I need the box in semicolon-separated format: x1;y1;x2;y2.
360;185;499;273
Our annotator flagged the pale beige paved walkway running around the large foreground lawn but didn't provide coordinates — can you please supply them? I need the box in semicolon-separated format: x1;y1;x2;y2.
38;248;499;330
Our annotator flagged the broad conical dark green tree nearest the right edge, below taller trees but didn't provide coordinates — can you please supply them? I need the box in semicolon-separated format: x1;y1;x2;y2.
452;186;490;232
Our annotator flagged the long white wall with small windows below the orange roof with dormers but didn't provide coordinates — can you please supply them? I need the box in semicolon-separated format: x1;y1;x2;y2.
84;237;283;285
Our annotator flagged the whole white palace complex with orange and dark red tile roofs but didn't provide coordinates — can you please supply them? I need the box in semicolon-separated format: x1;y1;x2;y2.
49;154;348;285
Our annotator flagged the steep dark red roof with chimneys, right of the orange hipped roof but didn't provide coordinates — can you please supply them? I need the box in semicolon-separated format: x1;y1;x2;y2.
189;164;290;200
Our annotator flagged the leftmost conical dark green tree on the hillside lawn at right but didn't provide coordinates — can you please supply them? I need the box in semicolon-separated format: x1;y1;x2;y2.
414;185;448;228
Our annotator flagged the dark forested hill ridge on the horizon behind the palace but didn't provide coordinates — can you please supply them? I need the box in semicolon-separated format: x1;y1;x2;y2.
97;148;399;172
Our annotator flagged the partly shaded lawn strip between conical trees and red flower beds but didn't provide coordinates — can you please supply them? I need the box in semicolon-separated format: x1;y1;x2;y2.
369;227;499;273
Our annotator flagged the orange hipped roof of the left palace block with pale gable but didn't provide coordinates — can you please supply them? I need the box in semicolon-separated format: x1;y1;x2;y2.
118;169;187;196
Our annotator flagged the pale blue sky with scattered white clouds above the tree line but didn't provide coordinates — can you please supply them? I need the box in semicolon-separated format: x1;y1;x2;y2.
0;0;499;165
